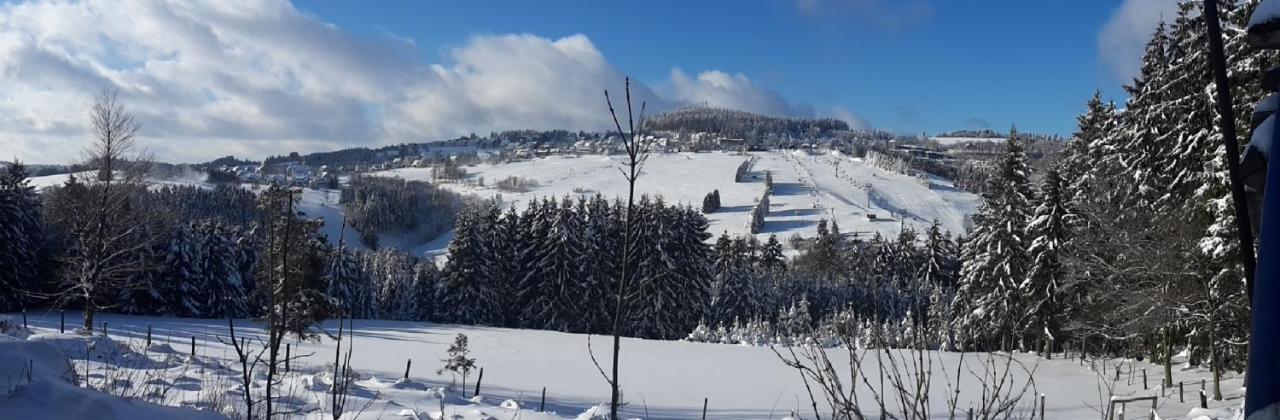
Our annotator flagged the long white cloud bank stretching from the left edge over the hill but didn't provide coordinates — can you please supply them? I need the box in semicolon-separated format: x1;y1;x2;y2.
0;0;839;163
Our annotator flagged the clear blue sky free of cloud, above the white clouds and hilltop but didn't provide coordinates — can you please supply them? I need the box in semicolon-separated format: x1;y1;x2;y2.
298;0;1141;134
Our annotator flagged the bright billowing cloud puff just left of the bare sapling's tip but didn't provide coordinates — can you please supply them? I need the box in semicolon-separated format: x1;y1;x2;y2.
384;35;671;137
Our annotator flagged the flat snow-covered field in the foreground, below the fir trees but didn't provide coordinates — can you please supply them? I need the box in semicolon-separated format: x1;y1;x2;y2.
0;312;1242;420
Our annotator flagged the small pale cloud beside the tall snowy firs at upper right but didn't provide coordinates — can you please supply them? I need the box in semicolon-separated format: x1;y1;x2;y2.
1098;0;1178;82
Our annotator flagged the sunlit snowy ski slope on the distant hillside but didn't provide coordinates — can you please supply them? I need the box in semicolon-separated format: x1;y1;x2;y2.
375;151;979;252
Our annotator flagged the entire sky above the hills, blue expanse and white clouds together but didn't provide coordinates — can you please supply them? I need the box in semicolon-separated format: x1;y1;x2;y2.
0;0;1175;163
